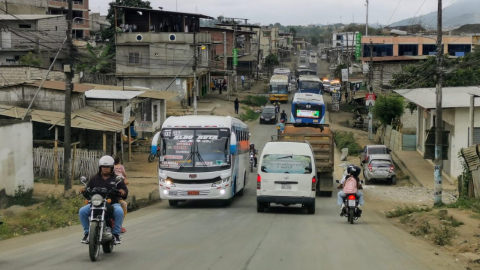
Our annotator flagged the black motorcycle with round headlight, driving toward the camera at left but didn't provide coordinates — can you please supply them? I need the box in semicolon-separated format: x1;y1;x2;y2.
80;176;123;262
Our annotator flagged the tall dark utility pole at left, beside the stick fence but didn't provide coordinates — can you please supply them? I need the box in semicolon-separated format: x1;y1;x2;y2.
63;0;75;191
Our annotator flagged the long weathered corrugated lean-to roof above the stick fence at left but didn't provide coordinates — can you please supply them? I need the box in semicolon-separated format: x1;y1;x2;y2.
0;105;135;132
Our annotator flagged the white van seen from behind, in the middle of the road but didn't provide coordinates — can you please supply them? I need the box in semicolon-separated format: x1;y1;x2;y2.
257;142;317;214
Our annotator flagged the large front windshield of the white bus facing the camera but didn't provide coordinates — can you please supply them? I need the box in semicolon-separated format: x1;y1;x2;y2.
160;129;230;172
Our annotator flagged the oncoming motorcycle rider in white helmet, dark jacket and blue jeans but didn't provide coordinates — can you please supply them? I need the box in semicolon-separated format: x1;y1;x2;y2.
78;156;128;245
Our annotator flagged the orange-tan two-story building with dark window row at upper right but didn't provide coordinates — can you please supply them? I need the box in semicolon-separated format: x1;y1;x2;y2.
361;36;473;91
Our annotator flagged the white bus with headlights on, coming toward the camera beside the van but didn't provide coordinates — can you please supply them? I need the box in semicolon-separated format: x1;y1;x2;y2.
152;115;250;206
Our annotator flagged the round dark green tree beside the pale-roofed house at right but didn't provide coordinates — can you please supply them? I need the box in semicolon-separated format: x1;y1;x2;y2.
372;95;405;125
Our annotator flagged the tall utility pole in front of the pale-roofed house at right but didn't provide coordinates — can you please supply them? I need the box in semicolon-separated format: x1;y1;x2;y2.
433;0;443;204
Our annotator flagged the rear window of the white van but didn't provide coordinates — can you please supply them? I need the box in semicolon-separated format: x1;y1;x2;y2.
261;154;313;174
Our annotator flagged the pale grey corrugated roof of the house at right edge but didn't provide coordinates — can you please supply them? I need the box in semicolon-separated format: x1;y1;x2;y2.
394;86;480;109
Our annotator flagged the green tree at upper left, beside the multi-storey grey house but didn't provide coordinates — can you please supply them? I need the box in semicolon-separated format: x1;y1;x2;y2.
78;44;115;73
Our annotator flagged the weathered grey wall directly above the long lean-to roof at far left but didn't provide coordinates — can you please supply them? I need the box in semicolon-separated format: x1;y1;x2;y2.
0;85;85;112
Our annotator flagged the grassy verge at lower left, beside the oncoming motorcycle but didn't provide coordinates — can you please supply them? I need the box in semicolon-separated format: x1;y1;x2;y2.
0;195;84;240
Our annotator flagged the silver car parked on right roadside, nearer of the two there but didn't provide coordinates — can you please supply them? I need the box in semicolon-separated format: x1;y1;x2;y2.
362;154;397;185
